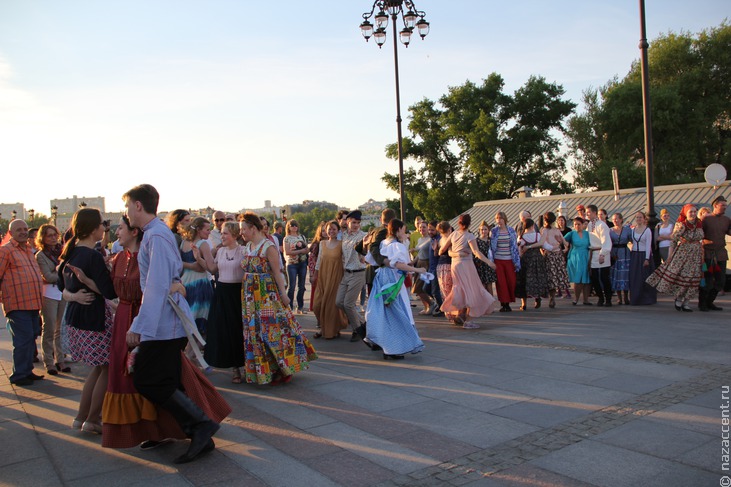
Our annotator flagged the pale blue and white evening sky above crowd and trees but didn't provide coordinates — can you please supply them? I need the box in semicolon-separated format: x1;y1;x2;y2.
0;0;731;214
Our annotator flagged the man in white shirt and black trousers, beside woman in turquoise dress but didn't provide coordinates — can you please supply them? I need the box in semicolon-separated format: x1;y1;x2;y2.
586;205;612;307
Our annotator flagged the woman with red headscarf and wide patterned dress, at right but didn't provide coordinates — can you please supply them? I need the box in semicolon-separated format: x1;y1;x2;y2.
647;204;703;312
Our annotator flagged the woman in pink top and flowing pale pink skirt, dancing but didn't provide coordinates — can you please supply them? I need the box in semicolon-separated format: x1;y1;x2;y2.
440;213;495;329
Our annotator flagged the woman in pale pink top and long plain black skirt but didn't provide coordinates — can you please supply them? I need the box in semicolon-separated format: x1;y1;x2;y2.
202;222;244;384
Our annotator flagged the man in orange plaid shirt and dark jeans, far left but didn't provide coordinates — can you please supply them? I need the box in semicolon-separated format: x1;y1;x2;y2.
0;220;43;386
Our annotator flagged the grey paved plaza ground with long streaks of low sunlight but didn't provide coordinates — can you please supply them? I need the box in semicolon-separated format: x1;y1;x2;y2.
0;296;731;487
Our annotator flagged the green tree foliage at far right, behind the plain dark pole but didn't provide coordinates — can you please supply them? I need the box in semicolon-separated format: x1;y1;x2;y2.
568;22;731;189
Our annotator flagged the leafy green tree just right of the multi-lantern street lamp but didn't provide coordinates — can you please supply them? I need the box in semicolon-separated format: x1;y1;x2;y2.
383;73;576;219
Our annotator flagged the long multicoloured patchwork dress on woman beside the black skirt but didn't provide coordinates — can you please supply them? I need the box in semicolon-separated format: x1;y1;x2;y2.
241;239;317;384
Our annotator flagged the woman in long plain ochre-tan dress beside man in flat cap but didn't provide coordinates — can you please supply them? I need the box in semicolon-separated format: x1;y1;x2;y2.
312;220;348;340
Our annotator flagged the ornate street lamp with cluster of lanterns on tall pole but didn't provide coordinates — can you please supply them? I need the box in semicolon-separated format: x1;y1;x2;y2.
360;0;429;221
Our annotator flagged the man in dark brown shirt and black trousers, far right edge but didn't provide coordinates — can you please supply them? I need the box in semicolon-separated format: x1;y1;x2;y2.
698;196;731;311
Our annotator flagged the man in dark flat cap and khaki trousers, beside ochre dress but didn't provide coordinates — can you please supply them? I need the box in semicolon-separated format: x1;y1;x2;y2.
335;210;366;342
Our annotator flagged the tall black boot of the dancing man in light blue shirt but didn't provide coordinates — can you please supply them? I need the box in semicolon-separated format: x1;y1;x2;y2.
160;389;221;463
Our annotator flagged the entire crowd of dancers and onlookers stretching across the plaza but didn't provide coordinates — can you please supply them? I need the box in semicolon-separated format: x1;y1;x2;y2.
0;185;731;463
